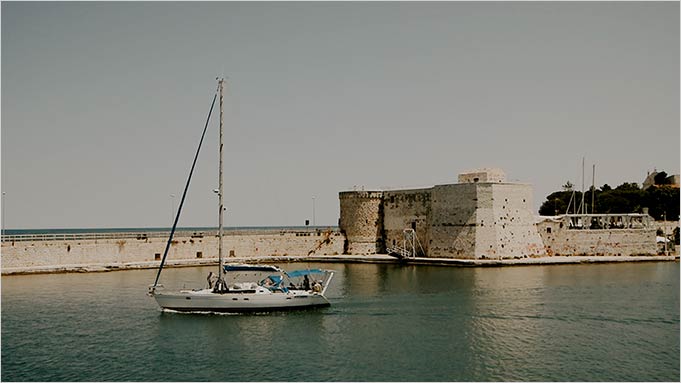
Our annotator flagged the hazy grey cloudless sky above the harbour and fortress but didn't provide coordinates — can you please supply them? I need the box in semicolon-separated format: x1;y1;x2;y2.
0;1;680;229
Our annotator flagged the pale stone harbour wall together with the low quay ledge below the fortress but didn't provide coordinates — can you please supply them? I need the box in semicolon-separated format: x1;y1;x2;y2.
2;228;679;275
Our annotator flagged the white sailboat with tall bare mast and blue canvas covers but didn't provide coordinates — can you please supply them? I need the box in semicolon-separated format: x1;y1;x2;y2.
148;78;333;313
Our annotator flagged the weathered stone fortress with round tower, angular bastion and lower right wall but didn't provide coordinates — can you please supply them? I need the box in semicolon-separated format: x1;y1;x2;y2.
339;168;657;259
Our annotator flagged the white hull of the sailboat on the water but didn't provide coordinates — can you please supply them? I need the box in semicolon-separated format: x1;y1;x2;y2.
154;289;330;312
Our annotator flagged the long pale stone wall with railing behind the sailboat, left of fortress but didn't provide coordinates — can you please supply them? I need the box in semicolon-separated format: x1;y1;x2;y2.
2;230;344;274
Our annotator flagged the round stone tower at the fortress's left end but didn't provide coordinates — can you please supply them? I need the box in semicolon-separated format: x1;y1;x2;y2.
339;191;385;254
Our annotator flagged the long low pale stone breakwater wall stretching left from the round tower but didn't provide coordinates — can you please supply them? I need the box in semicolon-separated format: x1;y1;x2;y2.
2;228;345;274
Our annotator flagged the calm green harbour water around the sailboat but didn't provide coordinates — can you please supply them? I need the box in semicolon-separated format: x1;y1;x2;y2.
2;262;679;381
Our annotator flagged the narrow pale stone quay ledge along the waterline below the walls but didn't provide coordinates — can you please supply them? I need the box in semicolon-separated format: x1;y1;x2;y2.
2;254;680;276
